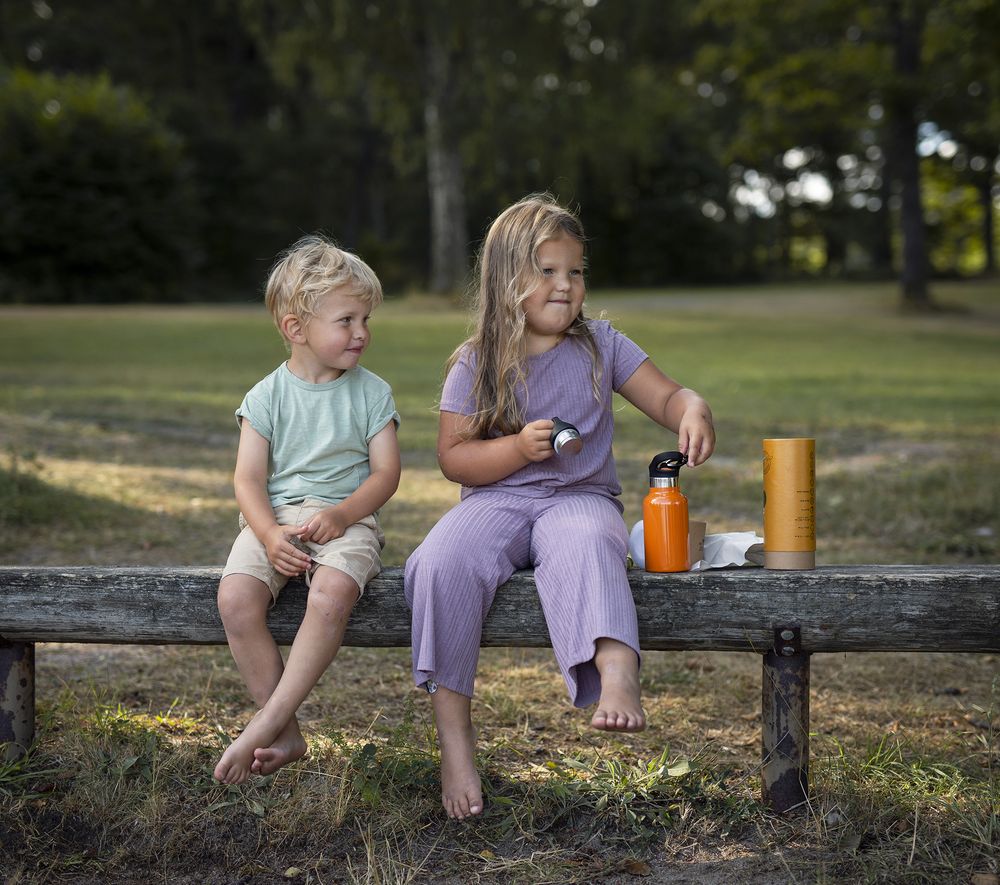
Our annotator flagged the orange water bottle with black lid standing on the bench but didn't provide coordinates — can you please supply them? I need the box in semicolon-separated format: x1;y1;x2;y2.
642;452;691;572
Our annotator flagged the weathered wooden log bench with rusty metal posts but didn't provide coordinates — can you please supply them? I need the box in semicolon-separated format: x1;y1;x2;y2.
0;565;1000;812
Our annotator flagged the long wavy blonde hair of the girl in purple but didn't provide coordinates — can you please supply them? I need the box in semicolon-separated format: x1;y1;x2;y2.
445;194;600;439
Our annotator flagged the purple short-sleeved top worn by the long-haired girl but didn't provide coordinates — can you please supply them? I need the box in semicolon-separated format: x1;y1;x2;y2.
441;320;647;503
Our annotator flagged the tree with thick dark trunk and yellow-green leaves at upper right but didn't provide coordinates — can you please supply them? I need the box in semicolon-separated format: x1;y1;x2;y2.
688;0;992;309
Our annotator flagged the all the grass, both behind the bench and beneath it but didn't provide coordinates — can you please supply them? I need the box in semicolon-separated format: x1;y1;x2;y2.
0;284;1000;883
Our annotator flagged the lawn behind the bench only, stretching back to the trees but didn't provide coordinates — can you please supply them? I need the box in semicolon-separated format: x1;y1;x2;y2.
0;284;1000;564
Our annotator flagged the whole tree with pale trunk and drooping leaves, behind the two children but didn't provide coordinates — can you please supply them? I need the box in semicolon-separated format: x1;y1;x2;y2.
244;0;656;292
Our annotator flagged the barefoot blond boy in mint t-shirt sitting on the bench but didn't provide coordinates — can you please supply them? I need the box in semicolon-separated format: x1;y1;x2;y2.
215;236;400;784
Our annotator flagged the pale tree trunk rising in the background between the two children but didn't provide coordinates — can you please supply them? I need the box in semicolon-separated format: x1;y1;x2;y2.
424;10;469;293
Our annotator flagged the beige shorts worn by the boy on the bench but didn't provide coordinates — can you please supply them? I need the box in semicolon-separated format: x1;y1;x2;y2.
222;498;385;600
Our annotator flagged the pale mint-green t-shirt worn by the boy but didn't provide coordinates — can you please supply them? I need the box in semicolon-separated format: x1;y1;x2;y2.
236;363;399;507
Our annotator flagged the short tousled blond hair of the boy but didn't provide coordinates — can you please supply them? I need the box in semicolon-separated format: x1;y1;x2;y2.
264;234;382;329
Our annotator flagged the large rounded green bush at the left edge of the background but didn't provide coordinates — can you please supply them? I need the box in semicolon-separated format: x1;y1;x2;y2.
0;70;196;302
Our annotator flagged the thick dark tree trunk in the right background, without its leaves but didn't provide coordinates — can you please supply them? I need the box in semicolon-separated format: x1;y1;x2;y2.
888;0;933;310
